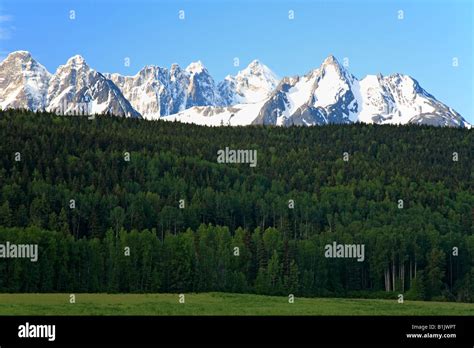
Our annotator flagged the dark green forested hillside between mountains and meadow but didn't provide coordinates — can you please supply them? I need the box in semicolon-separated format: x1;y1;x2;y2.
0;110;474;302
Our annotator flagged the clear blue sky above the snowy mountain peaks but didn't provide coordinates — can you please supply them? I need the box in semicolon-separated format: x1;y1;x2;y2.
0;0;474;123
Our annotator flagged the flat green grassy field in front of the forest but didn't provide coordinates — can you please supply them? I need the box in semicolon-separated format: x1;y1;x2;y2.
0;293;474;315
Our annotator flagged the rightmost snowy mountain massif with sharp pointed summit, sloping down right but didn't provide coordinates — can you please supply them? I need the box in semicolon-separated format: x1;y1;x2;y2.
253;56;470;127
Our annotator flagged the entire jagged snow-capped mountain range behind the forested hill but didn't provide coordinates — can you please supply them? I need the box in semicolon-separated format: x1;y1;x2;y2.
0;51;471;128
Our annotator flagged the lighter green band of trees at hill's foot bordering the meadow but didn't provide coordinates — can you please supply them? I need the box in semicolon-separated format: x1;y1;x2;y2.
0;225;474;302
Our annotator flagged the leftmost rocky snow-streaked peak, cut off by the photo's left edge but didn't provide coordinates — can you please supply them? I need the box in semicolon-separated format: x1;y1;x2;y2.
0;51;51;110
